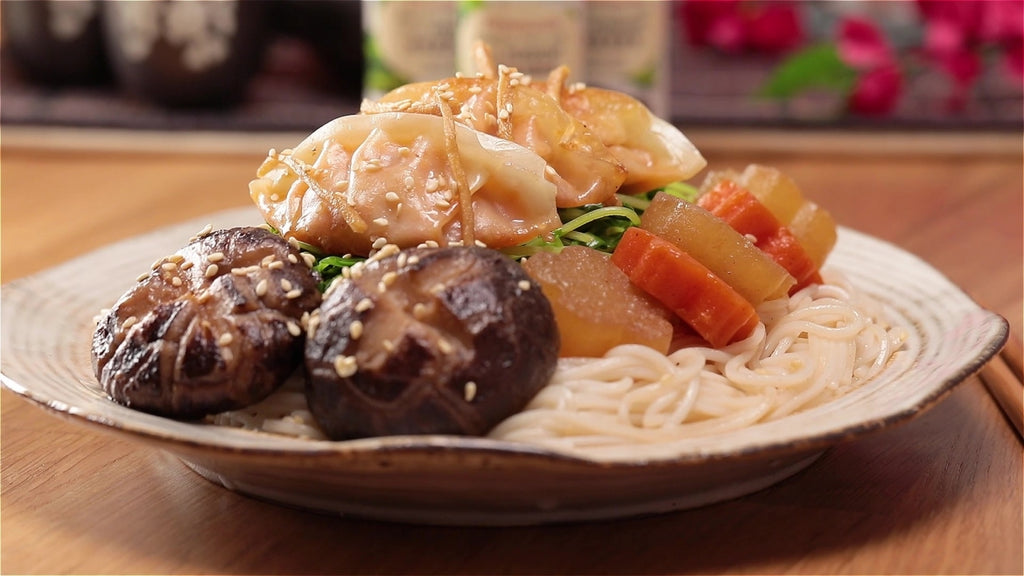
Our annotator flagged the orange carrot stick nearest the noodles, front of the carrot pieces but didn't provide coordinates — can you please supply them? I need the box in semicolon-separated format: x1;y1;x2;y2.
611;228;759;347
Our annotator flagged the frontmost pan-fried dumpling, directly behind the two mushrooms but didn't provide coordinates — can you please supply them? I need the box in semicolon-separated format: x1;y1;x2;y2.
249;113;561;255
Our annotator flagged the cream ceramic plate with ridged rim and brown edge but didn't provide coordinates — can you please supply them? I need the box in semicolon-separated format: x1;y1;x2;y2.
0;208;1008;525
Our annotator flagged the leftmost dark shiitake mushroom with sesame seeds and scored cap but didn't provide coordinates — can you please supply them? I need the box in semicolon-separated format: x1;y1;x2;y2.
92;228;321;419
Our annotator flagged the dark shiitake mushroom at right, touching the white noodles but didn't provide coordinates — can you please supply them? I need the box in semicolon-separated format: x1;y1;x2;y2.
305;247;559;440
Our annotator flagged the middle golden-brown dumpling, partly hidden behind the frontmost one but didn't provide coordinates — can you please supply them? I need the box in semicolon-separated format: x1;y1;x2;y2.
364;77;626;208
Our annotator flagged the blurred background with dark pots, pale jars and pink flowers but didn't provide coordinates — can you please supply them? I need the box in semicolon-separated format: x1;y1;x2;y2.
0;0;1024;132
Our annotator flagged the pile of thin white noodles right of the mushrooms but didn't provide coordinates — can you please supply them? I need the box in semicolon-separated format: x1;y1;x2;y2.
490;272;906;459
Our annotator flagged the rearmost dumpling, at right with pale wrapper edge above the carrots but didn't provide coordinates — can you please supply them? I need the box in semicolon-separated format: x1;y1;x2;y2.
536;82;708;194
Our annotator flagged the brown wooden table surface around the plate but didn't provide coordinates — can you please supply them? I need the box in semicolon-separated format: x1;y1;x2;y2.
0;127;1024;574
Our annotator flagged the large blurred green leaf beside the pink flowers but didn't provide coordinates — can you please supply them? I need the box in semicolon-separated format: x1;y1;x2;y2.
758;44;857;99
